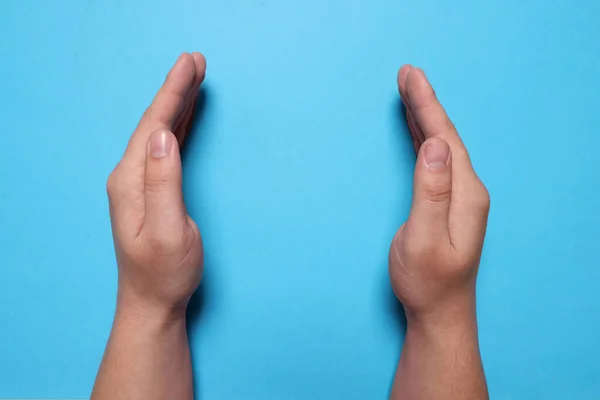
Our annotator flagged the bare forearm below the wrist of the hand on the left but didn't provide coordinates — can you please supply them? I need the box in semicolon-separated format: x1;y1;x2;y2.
91;300;193;400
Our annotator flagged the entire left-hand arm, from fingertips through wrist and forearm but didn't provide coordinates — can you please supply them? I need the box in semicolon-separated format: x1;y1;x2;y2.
91;53;206;400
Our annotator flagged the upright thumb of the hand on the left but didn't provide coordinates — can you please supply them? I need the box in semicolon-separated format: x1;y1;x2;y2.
144;129;187;235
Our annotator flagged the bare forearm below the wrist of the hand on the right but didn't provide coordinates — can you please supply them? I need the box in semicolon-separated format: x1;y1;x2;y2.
391;300;488;400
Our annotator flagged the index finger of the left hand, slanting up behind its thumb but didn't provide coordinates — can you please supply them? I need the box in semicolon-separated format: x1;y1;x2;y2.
123;53;196;166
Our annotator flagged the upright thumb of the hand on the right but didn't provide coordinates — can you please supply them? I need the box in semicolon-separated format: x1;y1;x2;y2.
408;138;452;242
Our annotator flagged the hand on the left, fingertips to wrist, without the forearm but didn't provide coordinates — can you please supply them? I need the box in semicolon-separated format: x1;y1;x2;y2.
107;53;206;315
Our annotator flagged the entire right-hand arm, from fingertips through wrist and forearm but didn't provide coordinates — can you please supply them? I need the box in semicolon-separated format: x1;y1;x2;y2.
389;65;490;400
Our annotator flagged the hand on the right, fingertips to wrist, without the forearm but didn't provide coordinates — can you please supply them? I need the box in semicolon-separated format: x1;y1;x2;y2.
389;65;490;324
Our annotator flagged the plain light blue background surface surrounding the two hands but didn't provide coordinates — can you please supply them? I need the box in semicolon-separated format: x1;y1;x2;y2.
0;0;600;399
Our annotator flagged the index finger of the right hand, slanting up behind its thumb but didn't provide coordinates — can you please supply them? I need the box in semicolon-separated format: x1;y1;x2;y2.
405;68;473;177
